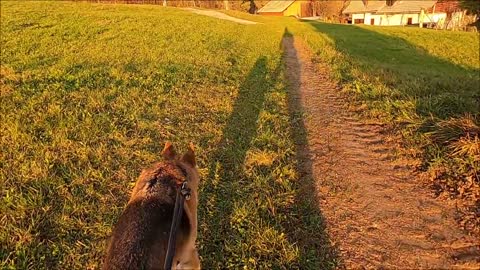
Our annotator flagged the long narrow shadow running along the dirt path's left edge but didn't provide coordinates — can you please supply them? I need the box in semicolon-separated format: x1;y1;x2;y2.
282;28;340;269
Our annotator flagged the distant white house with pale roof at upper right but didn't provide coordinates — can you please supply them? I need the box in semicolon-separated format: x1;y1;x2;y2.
343;0;460;25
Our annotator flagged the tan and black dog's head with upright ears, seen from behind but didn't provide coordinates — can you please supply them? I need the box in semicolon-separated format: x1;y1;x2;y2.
130;142;200;202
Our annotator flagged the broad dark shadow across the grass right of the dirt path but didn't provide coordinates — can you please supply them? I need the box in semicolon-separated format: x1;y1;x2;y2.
309;22;480;119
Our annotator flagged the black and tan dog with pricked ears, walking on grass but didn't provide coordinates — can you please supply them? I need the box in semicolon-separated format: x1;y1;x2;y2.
103;142;200;270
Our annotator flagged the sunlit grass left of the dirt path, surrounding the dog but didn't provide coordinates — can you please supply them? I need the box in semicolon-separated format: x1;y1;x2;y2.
0;2;335;269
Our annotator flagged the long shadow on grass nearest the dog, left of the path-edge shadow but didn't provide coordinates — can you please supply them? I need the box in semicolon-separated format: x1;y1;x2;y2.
199;57;278;269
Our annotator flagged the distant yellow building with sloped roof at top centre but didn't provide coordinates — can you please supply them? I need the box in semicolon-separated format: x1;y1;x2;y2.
258;0;313;17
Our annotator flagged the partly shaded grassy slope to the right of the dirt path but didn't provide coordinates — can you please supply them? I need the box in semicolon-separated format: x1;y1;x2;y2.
292;22;480;233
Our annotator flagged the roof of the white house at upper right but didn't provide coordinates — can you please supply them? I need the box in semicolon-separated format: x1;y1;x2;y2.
343;0;437;14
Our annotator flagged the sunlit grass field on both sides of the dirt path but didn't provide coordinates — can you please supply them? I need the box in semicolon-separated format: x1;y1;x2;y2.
0;1;480;269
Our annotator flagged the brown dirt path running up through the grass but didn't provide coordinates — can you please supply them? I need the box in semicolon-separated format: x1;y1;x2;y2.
283;37;480;269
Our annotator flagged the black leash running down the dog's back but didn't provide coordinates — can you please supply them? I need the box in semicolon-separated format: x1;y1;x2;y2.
164;181;190;270
